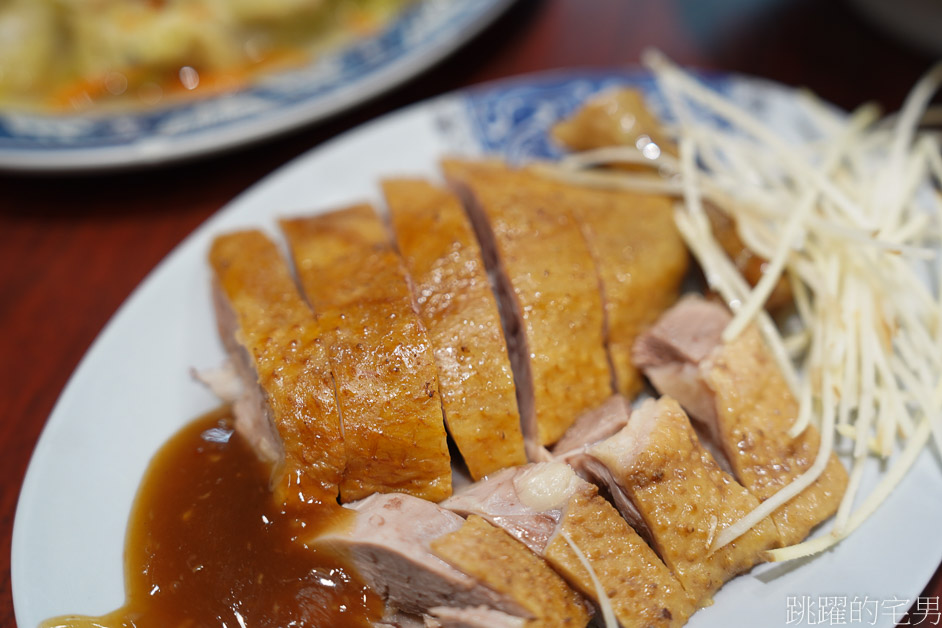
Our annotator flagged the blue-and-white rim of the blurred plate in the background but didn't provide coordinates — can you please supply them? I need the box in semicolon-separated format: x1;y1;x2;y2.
0;0;513;171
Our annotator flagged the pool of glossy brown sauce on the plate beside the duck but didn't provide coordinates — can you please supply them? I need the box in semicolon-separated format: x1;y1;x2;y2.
43;411;382;628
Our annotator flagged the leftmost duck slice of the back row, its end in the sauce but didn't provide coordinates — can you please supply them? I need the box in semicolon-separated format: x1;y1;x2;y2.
209;231;346;508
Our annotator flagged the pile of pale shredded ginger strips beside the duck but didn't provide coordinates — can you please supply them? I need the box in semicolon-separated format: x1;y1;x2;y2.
541;52;942;561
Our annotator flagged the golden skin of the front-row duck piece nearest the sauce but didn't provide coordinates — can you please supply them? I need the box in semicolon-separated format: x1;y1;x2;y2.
431;515;590;628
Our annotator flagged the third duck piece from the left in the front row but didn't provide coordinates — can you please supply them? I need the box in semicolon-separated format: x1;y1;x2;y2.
570;397;780;605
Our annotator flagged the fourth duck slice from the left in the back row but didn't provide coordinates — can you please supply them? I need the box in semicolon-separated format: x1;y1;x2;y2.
443;161;612;448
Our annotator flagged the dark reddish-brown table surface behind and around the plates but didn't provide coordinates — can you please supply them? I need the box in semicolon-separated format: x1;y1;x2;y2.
0;0;942;626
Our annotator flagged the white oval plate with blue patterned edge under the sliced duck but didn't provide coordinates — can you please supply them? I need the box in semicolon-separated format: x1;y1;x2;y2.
12;72;942;628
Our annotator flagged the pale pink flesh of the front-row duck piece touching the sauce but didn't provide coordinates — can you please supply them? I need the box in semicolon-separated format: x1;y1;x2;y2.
315;493;530;619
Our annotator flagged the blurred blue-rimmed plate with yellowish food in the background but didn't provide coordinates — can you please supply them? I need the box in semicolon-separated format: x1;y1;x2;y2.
0;0;511;170
